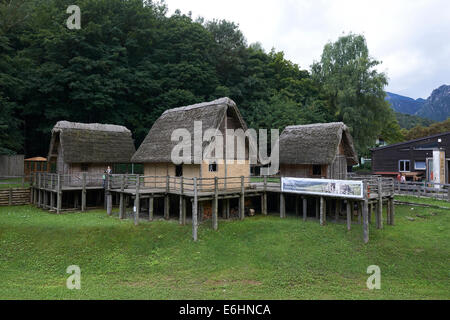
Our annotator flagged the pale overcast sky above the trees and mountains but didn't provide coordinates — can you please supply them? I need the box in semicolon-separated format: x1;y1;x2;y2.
165;0;450;98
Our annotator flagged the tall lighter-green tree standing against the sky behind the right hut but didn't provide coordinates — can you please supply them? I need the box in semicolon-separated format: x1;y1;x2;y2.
312;33;400;154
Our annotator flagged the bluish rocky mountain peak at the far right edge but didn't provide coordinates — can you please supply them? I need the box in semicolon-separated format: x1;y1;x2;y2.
415;85;450;121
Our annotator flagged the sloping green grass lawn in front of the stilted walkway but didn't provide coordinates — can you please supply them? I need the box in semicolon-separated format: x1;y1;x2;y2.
0;200;450;299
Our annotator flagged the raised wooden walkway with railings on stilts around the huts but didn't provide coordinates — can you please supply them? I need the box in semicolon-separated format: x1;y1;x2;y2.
31;173;394;242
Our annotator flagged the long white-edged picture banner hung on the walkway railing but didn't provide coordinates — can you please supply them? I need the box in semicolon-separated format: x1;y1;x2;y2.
281;177;363;199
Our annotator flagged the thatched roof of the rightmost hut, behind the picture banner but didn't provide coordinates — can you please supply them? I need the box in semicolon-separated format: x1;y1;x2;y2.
280;122;358;165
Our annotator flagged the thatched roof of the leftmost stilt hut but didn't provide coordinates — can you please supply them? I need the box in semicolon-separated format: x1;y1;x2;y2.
49;121;136;163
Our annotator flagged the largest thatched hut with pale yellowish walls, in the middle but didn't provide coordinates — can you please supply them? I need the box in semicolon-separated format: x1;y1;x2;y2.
132;98;250;184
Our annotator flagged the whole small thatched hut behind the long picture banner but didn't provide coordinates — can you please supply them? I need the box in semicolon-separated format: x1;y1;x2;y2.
280;122;358;179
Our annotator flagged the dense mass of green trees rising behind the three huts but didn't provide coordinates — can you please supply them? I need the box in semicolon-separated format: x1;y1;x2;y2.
0;0;398;156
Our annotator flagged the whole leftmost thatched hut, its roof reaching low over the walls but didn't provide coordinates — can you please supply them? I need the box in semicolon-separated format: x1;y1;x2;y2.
48;121;136;174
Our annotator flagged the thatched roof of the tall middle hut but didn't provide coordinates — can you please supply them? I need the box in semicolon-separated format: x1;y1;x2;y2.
132;98;247;162
